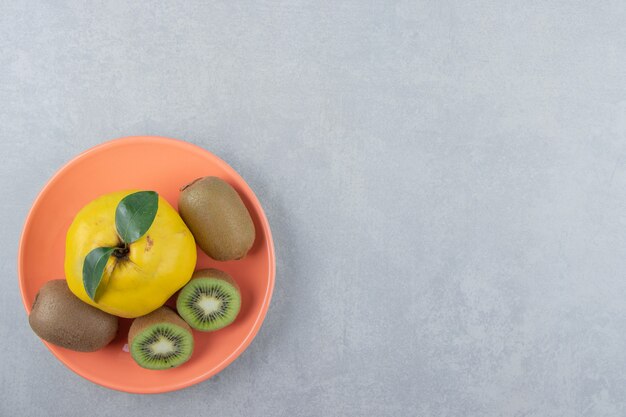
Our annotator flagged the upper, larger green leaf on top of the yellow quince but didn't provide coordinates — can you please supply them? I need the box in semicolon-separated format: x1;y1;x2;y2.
115;191;159;244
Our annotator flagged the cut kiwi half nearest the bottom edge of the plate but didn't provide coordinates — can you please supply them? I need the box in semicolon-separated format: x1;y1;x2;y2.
128;307;193;369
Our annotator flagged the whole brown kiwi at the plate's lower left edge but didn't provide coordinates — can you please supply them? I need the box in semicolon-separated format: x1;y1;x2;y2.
28;279;118;352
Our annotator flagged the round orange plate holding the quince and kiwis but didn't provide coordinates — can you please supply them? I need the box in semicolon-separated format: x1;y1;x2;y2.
18;136;276;393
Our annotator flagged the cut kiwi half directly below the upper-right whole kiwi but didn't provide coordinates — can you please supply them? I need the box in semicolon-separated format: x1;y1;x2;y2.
176;269;241;332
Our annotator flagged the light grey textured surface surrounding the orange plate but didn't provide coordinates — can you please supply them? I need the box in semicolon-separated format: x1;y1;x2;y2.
0;0;626;417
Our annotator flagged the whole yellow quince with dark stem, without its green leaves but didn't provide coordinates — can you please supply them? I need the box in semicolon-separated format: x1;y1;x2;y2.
65;190;196;318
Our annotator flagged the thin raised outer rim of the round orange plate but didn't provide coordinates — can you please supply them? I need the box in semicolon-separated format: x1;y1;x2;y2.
17;135;276;394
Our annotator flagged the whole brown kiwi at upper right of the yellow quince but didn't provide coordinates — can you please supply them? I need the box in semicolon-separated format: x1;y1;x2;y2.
178;177;255;261
